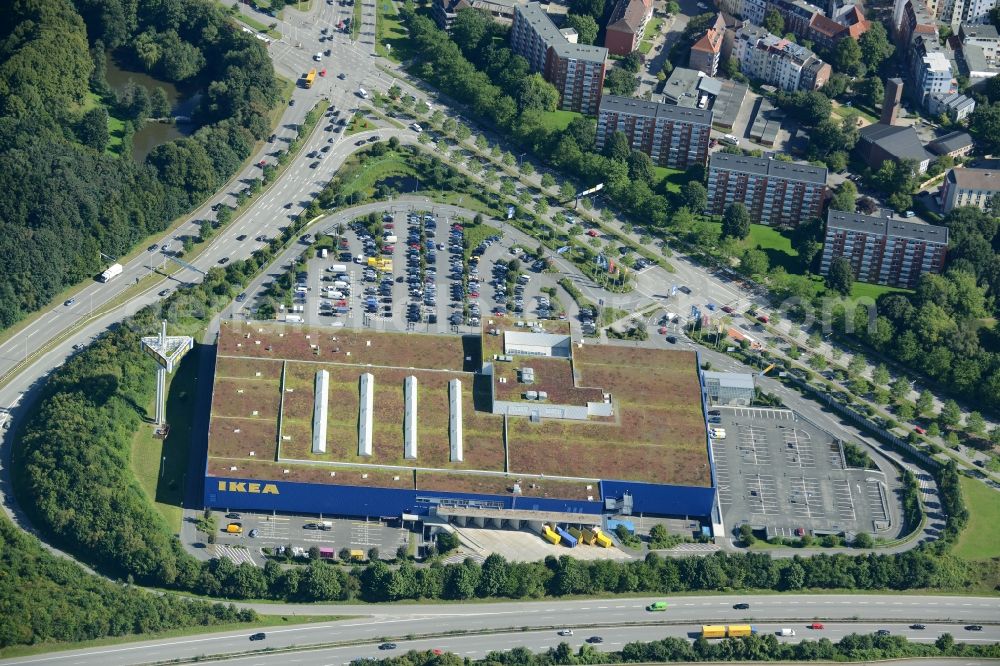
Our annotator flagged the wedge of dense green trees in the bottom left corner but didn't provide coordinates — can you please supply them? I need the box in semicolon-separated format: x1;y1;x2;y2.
0;510;257;648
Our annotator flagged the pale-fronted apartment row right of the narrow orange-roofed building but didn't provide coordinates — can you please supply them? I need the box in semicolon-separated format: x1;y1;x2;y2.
733;23;833;92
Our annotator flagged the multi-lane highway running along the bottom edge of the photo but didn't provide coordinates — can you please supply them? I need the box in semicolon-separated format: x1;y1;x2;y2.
0;595;1000;666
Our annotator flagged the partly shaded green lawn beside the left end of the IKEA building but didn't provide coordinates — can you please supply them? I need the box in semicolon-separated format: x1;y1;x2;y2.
131;342;198;533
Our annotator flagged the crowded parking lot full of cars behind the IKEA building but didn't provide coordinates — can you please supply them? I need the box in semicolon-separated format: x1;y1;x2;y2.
256;209;575;333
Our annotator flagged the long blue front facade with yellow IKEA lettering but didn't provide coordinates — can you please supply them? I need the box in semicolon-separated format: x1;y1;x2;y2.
205;476;715;517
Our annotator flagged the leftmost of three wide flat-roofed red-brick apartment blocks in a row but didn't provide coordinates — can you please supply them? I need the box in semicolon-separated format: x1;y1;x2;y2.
597;95;712;169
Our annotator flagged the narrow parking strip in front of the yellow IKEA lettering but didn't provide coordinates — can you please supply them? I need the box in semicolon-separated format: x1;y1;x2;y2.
215;511;409;565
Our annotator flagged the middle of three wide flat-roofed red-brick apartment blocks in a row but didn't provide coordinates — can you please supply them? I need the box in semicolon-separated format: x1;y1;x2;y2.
705;152;826;227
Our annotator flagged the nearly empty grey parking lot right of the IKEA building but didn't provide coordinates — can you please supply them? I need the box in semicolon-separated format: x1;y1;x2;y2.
710;407;900;537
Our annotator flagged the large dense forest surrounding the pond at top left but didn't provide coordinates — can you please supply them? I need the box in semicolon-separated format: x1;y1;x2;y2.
0;0;279;329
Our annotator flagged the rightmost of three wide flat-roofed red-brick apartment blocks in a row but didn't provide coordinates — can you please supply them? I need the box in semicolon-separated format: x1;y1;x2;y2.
820;210;948;289
